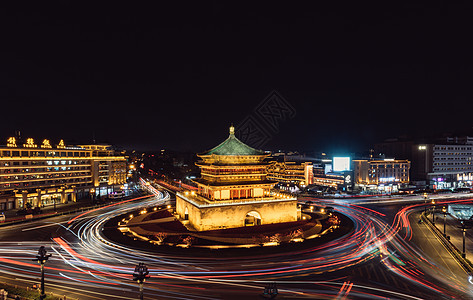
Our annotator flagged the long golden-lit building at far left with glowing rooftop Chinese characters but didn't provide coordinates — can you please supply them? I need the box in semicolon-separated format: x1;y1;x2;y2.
0;137;126;211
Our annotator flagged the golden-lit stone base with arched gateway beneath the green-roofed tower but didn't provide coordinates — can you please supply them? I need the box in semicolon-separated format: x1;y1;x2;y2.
176;193;300;231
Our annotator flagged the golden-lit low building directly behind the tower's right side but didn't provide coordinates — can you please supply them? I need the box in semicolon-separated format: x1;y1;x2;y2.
267;161;314;186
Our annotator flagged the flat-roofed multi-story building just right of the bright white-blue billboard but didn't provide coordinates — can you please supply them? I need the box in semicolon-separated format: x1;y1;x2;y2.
353;158;411;191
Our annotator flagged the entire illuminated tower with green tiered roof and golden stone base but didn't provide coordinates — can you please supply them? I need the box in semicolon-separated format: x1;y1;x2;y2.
176;126;299;231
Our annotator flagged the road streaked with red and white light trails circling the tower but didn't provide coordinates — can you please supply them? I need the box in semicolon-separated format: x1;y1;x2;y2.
0;189;472;299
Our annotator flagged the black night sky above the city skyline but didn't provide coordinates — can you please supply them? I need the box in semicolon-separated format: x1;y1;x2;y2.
0;1;473;152
